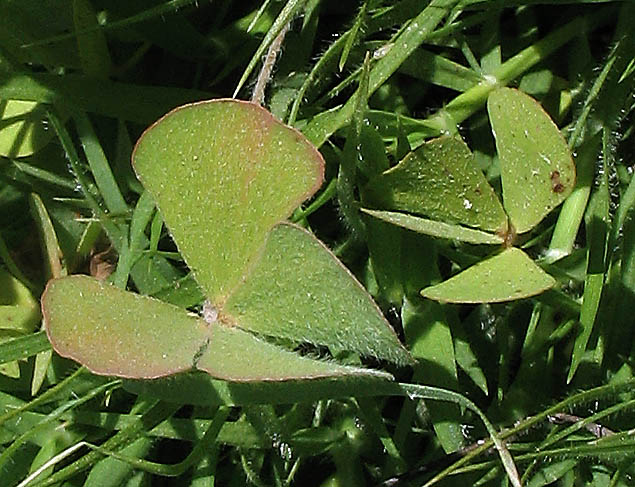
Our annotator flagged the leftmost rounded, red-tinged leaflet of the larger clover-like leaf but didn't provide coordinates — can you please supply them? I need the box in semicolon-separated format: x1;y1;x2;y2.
42;276;206;378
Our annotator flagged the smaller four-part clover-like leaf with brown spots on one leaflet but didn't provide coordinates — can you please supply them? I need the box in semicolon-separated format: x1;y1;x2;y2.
362;88;575;303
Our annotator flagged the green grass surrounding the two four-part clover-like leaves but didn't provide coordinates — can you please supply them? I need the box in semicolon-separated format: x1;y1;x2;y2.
0;0;635;487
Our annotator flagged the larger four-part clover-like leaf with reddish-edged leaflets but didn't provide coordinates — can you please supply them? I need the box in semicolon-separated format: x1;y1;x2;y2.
42;100;411;381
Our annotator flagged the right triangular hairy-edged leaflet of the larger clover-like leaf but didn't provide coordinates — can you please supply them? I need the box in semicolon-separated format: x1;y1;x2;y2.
223;224;410;364
